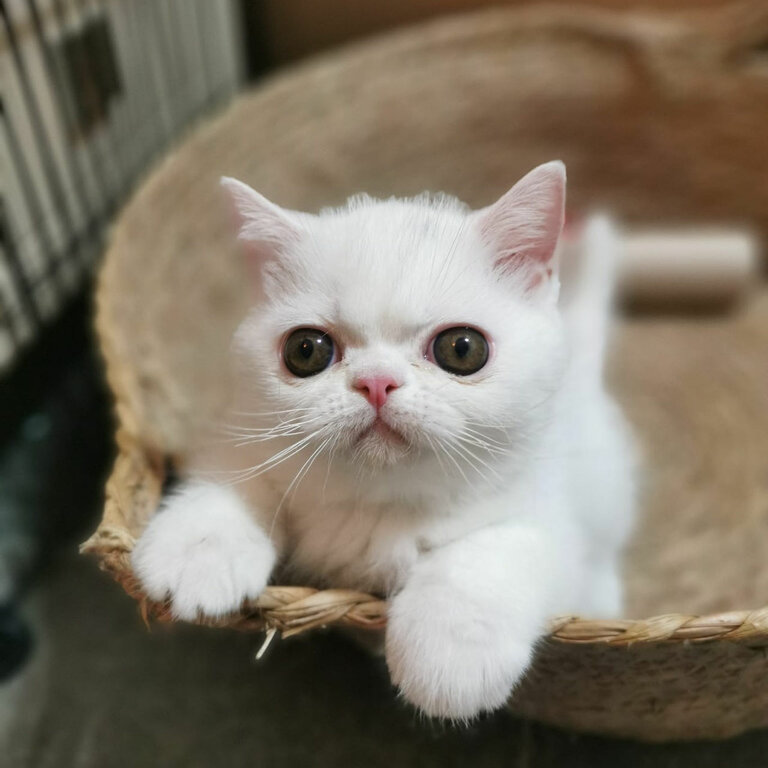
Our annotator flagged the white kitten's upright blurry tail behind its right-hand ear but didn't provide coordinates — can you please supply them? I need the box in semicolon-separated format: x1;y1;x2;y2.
560;214;621;380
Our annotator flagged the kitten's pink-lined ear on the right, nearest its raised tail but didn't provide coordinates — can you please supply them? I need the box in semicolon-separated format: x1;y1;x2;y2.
473;160;565;295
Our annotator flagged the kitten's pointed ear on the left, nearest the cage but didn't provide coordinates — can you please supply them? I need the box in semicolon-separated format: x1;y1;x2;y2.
221;176;301;266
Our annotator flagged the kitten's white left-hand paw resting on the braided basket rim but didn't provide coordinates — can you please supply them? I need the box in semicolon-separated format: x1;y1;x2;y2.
132;483;275;620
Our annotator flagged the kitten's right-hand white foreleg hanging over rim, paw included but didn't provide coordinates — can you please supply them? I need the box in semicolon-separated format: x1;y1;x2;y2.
386;526;569;720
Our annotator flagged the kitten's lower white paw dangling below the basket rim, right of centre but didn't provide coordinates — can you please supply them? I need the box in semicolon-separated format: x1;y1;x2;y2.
386;587;533;721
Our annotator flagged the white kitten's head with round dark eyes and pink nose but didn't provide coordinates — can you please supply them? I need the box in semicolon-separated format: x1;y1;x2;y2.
222;162;565;484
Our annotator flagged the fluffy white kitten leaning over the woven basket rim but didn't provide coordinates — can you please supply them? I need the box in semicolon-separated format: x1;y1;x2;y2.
133;162;633;719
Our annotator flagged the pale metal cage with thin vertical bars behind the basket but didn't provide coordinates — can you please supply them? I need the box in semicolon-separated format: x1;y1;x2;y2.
0;0;243;376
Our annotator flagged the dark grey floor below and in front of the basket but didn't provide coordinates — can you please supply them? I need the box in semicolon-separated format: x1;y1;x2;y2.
0;555;768;768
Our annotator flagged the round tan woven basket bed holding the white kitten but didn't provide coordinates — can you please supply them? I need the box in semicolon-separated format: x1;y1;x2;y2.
83;2;768;740
